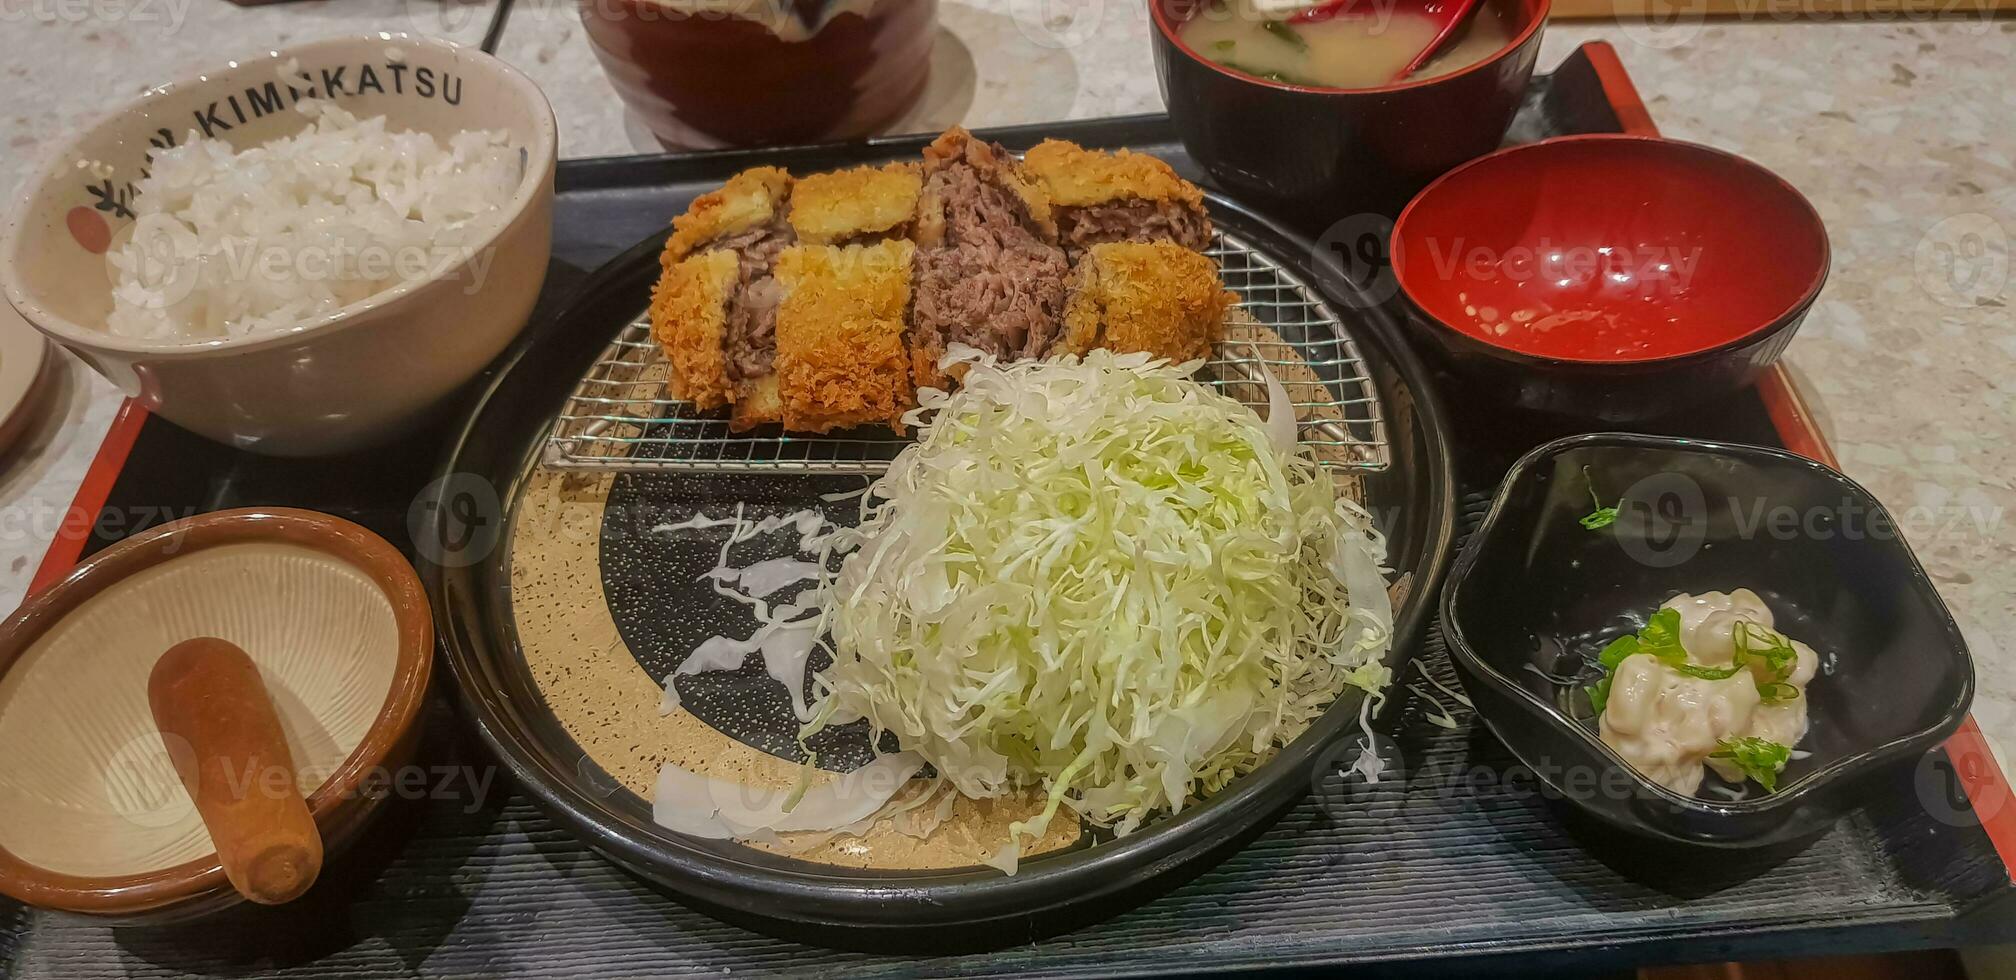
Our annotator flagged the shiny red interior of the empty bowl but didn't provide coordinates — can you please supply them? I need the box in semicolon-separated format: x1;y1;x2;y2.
1393;135;1826;361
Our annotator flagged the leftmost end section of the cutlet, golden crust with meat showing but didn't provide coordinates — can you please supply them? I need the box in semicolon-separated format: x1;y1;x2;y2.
651;167;796;432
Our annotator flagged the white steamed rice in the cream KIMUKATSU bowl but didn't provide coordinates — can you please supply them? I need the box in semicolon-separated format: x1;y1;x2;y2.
105;99;520;339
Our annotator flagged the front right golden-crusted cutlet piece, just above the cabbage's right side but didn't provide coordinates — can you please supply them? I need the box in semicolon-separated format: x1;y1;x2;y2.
1052;242;1238;363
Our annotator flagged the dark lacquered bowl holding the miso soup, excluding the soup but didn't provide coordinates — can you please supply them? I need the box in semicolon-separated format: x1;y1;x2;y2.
1149;0;1550;220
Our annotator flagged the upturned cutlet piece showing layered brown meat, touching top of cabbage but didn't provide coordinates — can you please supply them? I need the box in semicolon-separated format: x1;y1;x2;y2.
911;129;1070;387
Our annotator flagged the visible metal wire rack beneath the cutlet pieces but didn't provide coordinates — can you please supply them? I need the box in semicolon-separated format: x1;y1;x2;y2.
544;232;1391;476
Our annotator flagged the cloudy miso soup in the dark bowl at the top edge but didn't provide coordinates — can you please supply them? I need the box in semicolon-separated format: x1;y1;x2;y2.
1179;0;1512;89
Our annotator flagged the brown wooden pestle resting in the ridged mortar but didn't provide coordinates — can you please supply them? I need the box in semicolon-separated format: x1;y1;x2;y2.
147;637;323;905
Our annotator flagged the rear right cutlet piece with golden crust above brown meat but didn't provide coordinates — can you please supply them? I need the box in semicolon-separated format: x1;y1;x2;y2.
1022;139;1212;260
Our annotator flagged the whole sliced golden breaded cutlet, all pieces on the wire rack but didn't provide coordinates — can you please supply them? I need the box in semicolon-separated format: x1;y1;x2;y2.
651;129;1234;432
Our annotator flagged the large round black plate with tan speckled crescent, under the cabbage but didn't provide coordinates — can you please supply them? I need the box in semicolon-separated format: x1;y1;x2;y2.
421;178;1454;932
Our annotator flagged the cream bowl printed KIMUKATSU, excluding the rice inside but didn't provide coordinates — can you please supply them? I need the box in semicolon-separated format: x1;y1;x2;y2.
0;32;556;456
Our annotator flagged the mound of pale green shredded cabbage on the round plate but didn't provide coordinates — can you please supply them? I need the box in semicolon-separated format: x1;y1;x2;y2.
802;349;1393;847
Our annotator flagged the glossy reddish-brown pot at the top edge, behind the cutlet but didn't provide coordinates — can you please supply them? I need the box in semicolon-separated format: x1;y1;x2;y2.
579;0;937;149
